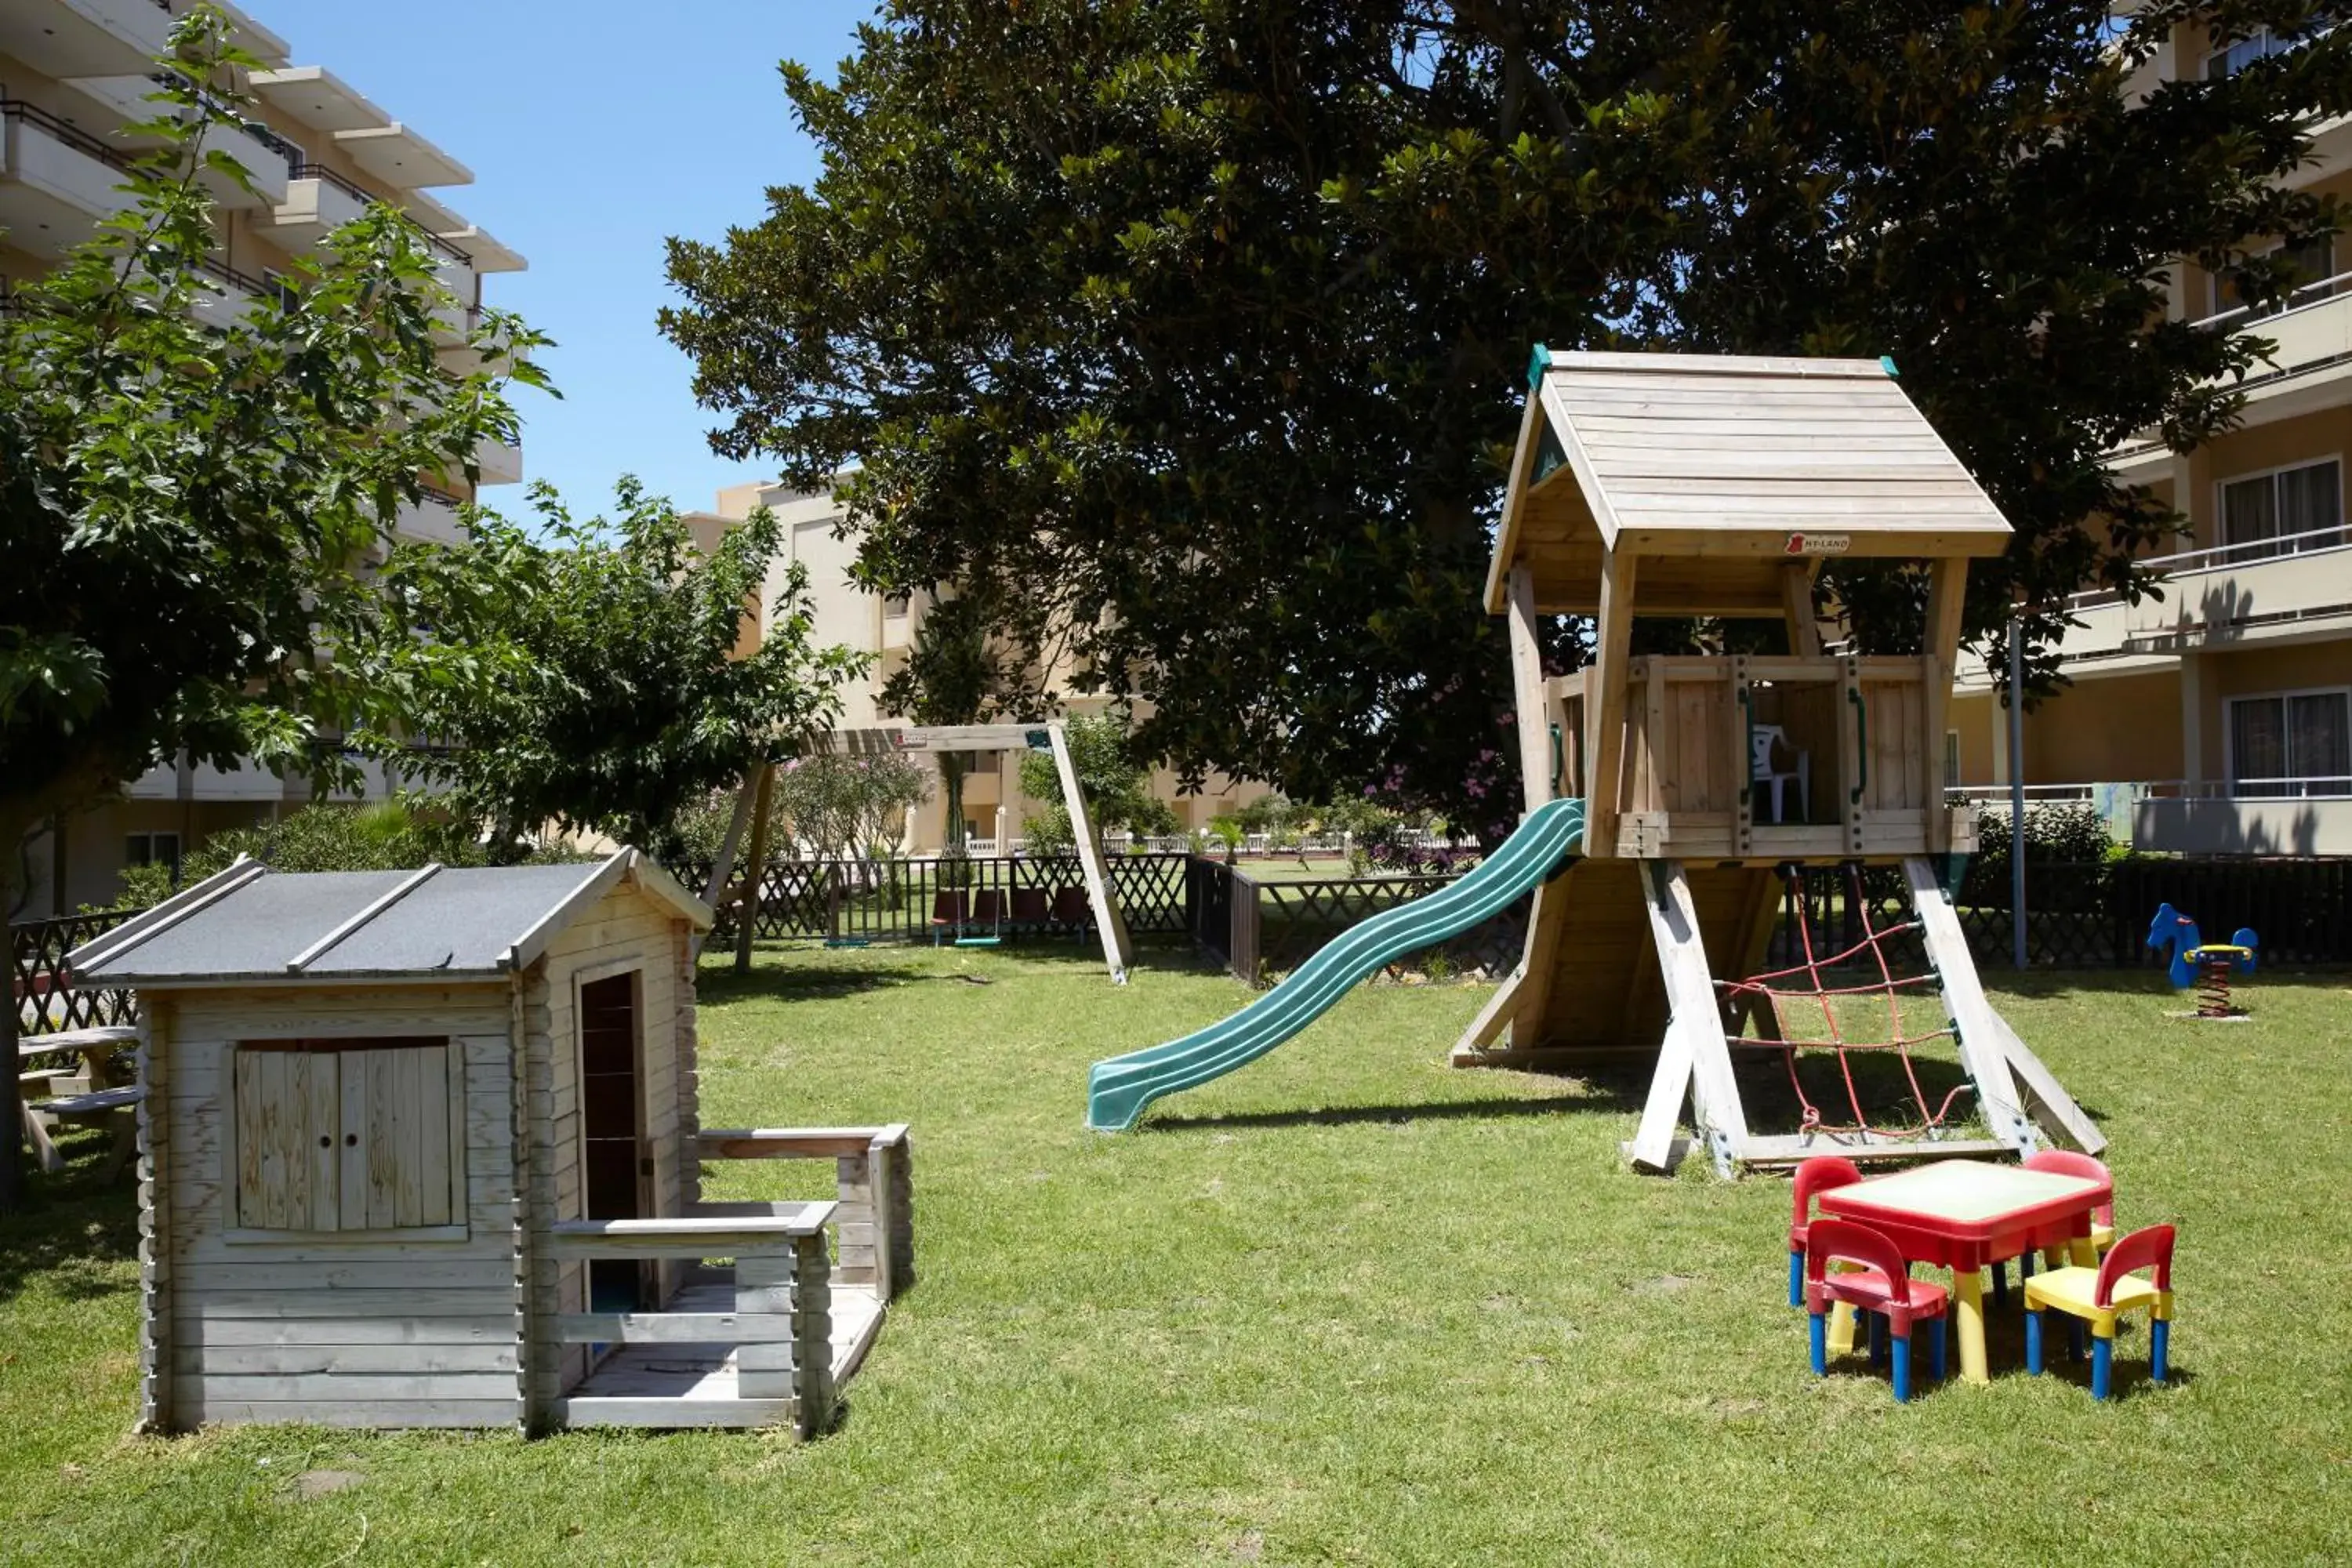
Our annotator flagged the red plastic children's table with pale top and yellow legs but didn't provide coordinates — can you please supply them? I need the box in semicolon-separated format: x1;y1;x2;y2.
1816;1159;2114;1382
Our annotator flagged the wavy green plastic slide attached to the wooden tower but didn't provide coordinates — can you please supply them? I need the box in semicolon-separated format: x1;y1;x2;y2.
1087;799;1585;1133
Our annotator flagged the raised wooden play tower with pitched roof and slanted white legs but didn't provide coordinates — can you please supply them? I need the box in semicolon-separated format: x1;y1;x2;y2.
1454;348;2103;1173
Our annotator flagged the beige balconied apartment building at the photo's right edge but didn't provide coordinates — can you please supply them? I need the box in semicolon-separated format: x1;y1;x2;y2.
1945;12;2352;855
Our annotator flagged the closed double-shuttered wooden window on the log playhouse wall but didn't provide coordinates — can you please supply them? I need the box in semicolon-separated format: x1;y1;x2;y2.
235;1036;466;1229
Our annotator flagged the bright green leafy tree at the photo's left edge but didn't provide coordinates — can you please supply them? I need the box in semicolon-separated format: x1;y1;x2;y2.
0;7;541;1206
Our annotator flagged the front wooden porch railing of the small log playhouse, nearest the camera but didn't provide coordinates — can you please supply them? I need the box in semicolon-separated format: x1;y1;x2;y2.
546;1203;837;1436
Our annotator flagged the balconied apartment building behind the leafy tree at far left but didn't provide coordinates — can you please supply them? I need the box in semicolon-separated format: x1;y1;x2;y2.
0;0;524;914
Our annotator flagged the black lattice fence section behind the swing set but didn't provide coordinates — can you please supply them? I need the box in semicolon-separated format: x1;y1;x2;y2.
673;853;1190;945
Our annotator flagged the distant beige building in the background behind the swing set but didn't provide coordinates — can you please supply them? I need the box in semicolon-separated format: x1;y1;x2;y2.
687;485;1268;853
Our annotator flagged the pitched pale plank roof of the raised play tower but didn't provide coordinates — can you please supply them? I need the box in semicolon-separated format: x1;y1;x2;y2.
1486;346;2009;616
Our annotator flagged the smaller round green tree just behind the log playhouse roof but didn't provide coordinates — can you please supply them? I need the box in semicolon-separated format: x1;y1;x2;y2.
365;480;866;855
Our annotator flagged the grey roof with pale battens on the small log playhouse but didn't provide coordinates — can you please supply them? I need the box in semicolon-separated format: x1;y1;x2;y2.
66;848;710;985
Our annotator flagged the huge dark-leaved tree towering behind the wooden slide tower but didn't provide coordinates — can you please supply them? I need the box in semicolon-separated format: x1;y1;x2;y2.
663;0;2352;806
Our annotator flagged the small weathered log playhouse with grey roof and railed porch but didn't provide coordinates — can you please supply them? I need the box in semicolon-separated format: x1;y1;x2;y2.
68;851;913;1434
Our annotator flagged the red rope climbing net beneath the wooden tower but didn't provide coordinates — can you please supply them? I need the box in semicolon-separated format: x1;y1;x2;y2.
1717;865;1973;1138
